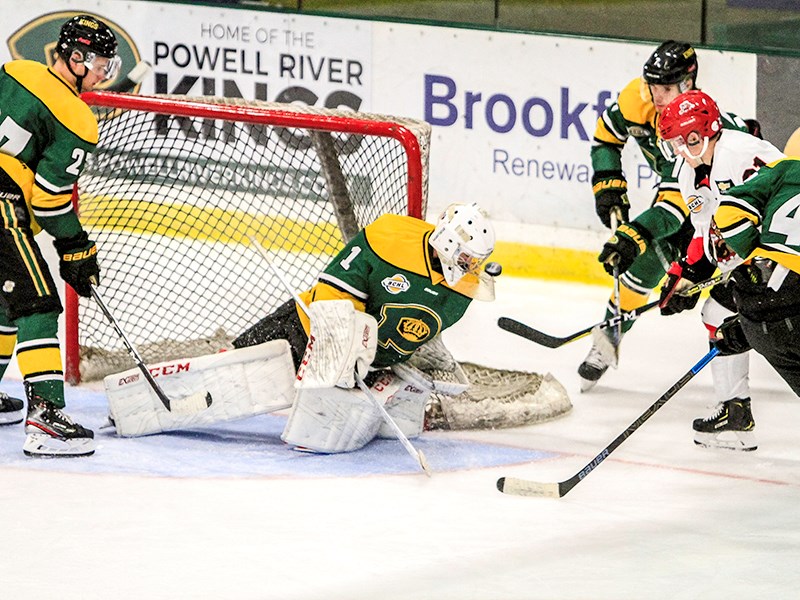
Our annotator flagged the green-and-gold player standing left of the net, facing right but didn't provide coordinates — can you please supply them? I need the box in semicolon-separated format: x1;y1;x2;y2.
0;15;120;456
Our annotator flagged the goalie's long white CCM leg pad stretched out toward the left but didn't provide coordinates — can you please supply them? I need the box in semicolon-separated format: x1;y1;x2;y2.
103;340;294;437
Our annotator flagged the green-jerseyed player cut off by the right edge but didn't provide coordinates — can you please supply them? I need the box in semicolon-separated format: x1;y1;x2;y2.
714;158;800;396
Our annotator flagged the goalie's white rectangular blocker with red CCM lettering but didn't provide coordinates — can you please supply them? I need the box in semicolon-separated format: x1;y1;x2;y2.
295;300;378;388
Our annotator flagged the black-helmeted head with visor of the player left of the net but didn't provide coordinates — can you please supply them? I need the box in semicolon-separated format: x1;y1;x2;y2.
56;15;121;91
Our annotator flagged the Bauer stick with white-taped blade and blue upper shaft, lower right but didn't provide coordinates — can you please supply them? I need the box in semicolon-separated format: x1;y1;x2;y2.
497;348;719;498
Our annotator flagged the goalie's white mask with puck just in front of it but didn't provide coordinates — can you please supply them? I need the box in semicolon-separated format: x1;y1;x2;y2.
429;204;495;286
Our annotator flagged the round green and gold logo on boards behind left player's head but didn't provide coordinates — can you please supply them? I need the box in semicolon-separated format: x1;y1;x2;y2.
8;10;141;91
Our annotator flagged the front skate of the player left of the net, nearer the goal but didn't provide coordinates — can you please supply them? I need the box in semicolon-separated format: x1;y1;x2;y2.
22;384;94;457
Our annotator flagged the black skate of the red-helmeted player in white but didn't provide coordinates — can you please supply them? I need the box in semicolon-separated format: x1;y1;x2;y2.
692;398;758;452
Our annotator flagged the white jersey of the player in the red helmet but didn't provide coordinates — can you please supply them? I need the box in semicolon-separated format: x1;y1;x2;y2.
678;129;784;272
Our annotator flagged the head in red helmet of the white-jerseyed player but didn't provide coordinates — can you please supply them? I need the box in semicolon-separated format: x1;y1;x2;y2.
658;90;722;159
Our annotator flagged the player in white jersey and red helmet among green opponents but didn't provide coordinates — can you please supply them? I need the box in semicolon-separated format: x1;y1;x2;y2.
659;90;784;450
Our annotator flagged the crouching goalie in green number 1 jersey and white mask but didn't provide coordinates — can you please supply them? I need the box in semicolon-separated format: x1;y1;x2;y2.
233;204;495;452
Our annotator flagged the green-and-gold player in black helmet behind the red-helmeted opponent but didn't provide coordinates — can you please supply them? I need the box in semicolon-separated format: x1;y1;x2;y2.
578;40;760;391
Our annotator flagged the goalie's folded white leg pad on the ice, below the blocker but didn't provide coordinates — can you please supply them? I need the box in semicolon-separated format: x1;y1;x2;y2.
281;387;383;454
